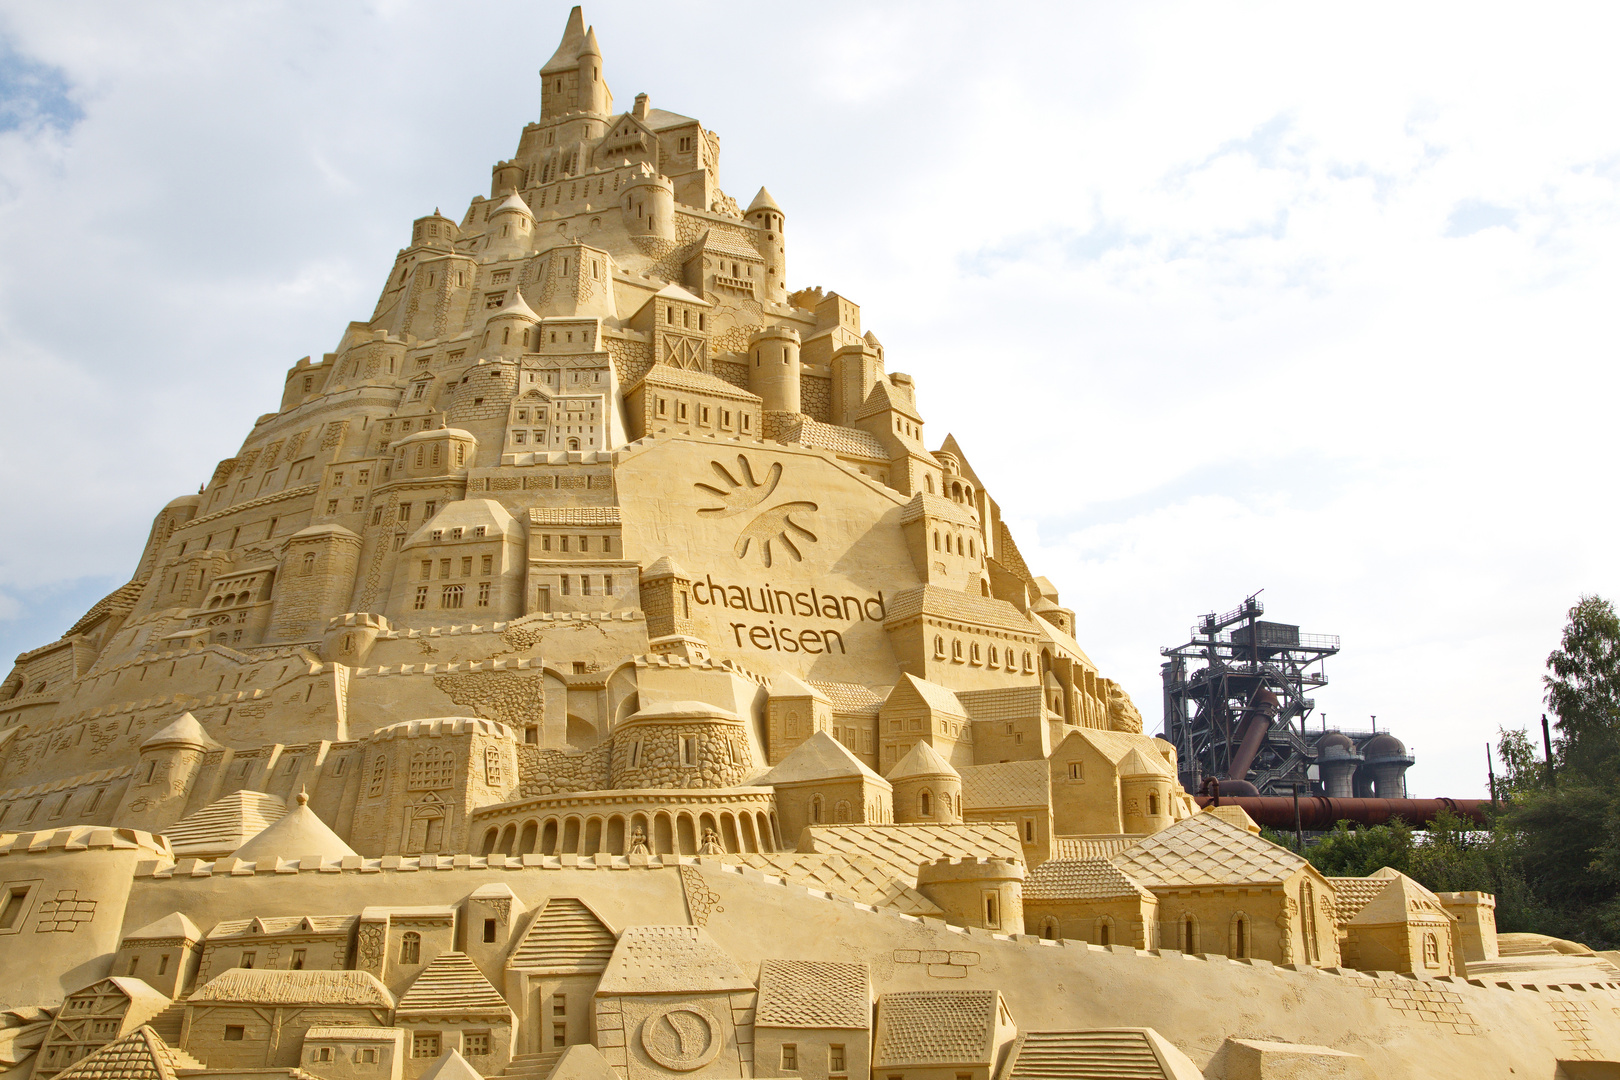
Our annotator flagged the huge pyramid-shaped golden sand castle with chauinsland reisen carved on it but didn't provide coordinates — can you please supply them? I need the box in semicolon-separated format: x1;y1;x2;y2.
0;8;1620;1080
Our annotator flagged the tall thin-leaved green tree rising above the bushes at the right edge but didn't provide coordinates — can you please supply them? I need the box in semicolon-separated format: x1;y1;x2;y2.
1542;596;1620;784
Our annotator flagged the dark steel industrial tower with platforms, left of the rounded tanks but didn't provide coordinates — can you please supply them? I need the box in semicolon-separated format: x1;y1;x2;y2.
1160;594;1338;795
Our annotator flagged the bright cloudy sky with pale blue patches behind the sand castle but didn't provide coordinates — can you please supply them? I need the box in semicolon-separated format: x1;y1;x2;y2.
0;0;1620;797
